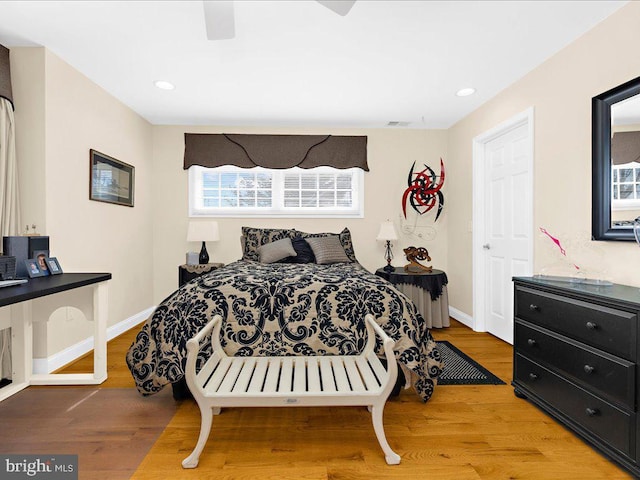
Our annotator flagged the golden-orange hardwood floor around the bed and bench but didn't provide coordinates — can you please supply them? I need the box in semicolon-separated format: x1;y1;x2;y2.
16;320;631;480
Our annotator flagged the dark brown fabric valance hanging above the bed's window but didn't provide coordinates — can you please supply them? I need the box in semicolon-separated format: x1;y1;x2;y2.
184;133;369;172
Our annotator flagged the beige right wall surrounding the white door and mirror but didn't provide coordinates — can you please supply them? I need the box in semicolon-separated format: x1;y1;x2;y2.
447;2;640;315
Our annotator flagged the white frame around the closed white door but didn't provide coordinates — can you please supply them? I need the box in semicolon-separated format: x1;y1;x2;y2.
472;107;534;332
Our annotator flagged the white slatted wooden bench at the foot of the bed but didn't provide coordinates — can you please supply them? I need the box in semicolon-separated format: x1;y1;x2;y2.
182;315;400;468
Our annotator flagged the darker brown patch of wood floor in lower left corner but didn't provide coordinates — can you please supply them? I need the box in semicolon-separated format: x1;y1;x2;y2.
0;386;177;480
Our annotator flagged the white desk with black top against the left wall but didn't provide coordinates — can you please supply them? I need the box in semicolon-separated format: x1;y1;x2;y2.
0;273;111;401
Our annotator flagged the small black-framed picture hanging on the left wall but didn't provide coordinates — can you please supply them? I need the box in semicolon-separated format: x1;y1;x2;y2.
89;149;135;207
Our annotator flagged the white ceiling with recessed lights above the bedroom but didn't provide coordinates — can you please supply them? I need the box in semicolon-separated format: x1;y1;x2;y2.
0;0;627;128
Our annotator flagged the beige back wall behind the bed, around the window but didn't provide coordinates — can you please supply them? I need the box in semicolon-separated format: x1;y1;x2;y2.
153;126;448;302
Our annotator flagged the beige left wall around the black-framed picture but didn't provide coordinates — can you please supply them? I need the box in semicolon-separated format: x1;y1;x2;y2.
11;48;153;356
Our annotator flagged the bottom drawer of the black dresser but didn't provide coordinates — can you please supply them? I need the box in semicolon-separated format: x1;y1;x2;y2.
514;354;635;457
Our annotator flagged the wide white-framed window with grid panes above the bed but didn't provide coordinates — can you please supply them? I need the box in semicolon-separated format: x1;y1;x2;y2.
189;166;364;217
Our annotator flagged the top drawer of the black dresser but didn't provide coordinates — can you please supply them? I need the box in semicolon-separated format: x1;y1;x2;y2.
514;286;638;360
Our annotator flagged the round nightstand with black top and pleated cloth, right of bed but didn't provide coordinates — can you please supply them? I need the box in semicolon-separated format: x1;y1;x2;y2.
376;267;450;328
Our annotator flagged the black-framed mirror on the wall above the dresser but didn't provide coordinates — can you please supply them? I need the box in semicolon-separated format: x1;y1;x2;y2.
591;77;640;240
